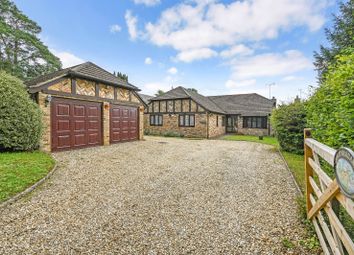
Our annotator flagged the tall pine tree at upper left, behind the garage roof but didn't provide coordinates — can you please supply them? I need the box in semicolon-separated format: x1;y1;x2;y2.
0;0;61;80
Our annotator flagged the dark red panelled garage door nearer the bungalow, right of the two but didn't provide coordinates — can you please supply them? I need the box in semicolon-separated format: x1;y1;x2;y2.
110;104;138;143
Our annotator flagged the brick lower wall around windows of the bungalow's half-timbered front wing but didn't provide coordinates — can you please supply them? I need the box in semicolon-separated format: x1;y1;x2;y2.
144;113;207;138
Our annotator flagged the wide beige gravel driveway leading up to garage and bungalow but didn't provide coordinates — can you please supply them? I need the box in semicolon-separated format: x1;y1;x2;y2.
0;137;314;254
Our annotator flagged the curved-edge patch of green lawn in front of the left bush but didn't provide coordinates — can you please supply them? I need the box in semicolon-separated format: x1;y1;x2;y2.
0;151;54;202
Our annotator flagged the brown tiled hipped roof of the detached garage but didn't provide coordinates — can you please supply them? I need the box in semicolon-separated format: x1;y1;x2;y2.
26;62;139;91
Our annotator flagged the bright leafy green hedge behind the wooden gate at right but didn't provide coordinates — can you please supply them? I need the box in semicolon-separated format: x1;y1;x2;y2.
306;49;354;148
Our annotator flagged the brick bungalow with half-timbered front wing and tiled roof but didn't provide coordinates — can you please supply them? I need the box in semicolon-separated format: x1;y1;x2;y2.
144;87;276;138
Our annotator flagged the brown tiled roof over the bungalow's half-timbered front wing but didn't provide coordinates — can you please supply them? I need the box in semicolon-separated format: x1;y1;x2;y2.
150;86;224;113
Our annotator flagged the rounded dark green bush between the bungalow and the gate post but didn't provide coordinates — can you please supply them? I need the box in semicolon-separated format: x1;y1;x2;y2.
271;100;306;154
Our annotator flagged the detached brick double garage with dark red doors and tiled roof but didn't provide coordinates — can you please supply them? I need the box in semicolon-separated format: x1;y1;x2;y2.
26;62;145;151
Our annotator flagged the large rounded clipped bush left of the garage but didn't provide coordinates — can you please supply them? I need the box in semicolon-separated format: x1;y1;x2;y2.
0;72;42;150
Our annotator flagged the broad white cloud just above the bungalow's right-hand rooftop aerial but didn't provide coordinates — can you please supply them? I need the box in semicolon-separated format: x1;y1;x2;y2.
230;50;312;80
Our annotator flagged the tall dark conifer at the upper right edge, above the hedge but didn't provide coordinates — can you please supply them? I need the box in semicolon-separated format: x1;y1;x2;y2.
314;0;354;81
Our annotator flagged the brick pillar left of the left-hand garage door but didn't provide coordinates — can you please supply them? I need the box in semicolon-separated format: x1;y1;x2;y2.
38;92;52;152
